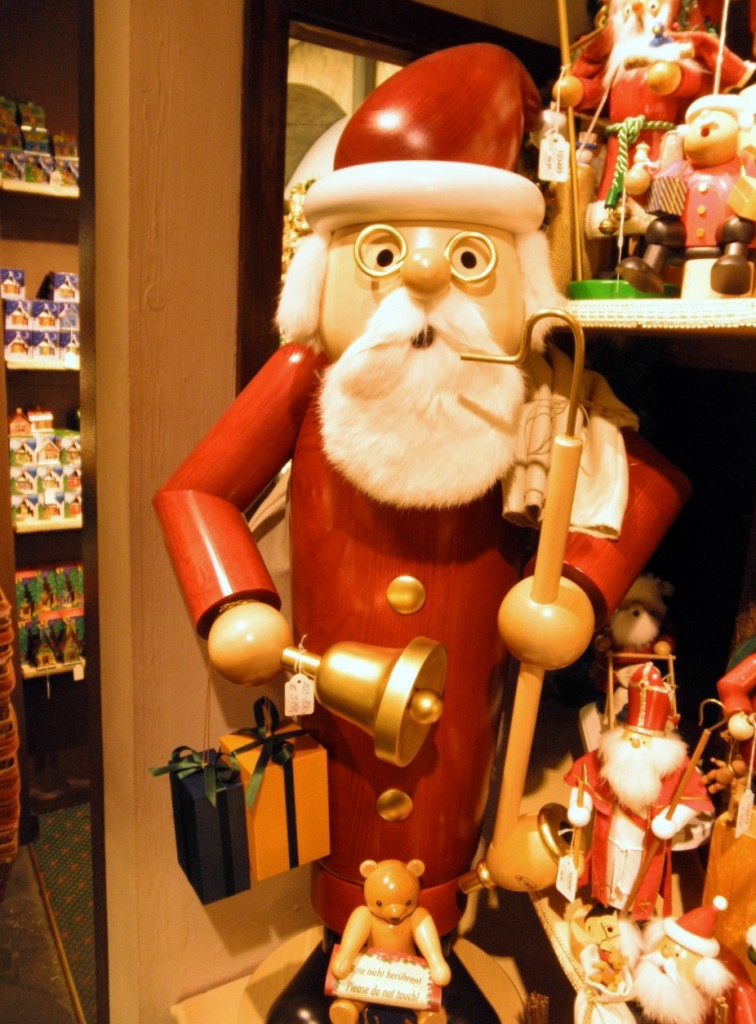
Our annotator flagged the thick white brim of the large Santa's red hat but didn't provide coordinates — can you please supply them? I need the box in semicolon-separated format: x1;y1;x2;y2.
304;160;545;234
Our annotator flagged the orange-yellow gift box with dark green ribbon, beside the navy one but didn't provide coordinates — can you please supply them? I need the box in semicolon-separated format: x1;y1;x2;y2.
219;722;330;881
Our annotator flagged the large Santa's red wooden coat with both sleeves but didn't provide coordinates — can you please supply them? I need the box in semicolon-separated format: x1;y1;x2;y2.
155;345;687;934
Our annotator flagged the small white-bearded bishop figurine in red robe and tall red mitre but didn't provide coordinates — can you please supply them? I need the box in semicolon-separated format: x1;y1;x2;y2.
564;662;713;921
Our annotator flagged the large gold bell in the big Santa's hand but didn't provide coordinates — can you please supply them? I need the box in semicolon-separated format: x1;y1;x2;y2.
281;637;447;768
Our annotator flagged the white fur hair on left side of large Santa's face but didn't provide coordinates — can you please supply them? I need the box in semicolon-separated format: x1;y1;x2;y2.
276;234;331;351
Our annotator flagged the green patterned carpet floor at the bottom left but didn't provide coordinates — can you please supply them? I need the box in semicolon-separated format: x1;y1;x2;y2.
34;804;96;1024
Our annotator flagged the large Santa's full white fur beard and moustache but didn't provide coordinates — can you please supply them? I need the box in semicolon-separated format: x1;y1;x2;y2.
320;288;524;508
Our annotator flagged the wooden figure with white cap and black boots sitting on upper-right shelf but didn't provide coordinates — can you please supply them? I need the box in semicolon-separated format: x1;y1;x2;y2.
617;95;756;295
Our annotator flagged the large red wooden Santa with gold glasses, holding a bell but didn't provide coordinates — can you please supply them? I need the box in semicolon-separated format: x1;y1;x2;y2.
155;44;686;1024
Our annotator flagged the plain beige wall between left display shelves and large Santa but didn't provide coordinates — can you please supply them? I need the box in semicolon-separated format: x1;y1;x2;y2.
89;0;581;1024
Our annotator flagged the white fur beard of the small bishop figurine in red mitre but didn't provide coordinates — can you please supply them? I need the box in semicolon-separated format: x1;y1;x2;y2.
598;725;685;816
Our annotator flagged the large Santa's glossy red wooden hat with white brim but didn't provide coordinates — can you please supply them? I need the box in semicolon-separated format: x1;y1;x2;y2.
304;43;544;233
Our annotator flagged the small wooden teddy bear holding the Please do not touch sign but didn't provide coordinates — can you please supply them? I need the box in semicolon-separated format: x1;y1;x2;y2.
329;859;452;1024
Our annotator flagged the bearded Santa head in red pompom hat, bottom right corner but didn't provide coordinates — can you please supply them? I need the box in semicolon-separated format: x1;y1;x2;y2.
633;896;736;1024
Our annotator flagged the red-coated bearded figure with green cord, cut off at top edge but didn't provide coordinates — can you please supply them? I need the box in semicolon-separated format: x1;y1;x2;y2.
555;0;754;231
